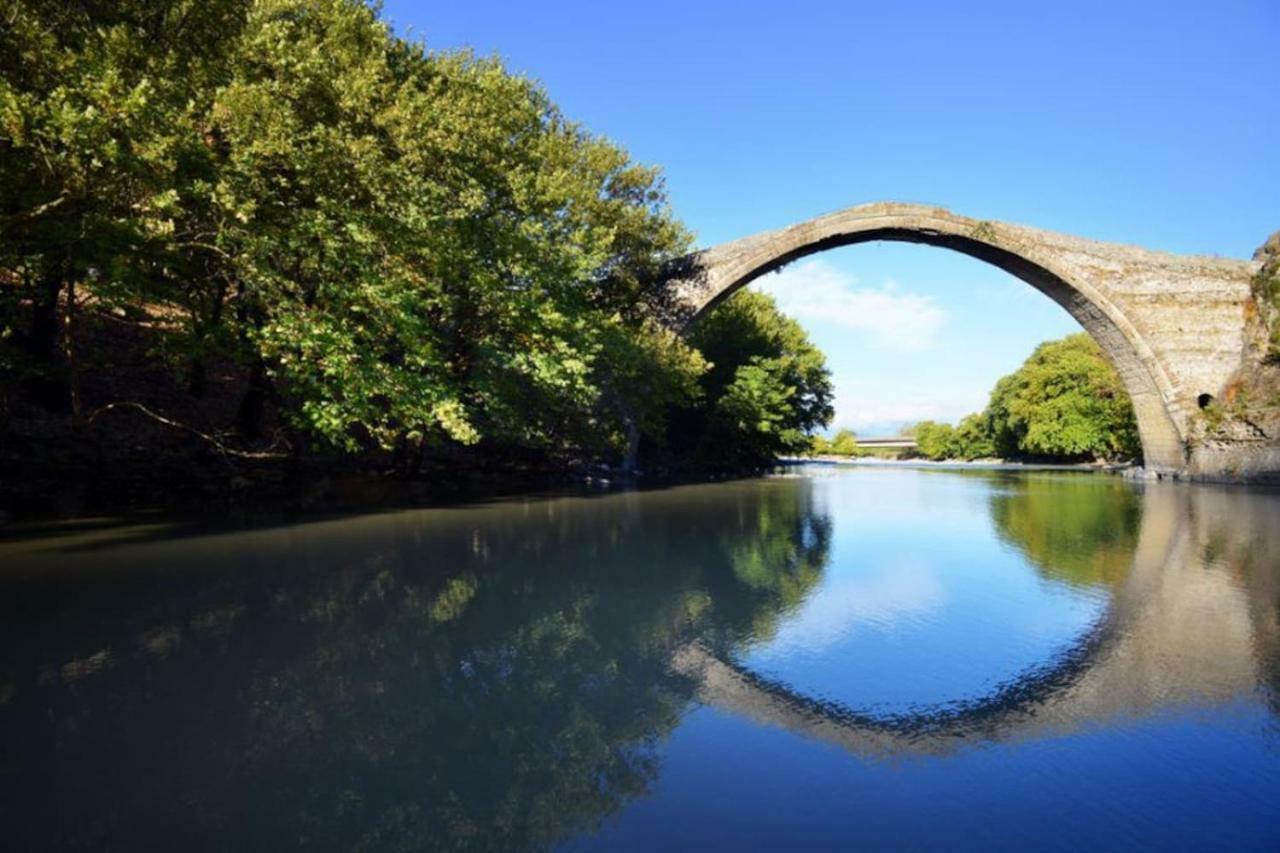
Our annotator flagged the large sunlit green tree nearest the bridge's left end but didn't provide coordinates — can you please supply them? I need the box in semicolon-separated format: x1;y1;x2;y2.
203;0;699;451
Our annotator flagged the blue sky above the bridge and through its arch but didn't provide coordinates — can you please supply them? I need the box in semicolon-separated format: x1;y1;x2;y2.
384;0;1280;434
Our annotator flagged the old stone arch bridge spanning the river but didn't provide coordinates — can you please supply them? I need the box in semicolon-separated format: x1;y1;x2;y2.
668;202;1280;478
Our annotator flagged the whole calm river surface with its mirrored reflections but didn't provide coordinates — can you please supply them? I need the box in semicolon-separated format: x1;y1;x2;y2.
0;469;1280;850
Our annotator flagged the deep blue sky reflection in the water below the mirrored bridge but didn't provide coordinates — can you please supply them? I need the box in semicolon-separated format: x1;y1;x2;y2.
573;703;1280;852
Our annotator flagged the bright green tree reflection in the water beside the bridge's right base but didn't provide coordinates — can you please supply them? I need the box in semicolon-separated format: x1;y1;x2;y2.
991;476;1142;588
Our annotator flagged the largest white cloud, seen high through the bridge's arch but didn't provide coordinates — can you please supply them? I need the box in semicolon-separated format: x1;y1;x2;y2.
758;260;946;352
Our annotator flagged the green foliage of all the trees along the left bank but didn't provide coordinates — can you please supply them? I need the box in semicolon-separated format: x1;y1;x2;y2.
0;0;721;471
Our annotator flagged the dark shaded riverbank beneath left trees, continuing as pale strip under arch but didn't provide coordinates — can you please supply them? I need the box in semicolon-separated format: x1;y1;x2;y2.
0;432;1140;530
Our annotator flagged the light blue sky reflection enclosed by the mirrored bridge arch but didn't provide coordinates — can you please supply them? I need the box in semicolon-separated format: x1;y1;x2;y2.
739;470;1106;713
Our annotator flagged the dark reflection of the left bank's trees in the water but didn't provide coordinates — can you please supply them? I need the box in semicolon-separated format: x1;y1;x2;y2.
0;480;829;849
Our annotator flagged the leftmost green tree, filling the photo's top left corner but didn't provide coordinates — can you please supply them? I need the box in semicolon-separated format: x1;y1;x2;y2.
0;0;248;414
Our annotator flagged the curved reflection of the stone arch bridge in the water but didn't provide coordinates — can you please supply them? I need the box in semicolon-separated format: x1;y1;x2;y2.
672;487;1280;756
